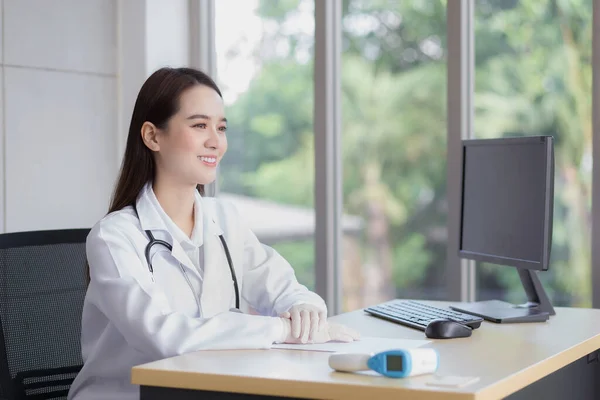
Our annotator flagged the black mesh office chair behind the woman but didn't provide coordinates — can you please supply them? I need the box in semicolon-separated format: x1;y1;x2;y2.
0;229;89;400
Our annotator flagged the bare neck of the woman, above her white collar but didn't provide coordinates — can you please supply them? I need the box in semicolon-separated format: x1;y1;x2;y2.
152;176;196;237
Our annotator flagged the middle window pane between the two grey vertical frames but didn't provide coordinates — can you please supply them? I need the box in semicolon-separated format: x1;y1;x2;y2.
341;0;447;311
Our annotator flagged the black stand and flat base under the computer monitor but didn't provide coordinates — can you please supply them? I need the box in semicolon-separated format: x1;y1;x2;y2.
450;268;556;323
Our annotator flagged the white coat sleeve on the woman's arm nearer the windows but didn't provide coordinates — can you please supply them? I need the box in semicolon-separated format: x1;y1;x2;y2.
240;212;327;316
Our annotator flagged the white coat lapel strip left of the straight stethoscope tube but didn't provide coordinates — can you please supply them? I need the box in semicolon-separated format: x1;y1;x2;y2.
201;198;235;317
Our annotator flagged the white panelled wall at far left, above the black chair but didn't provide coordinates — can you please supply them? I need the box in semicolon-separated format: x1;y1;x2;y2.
0;0;120;232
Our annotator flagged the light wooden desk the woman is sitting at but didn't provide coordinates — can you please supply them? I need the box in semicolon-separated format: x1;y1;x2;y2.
132;302;600;400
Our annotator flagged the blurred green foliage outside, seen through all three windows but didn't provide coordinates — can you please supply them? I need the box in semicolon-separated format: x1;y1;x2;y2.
221;0;592;306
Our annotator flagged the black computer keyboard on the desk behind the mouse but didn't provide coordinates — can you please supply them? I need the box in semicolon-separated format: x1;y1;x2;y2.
365;300;483;331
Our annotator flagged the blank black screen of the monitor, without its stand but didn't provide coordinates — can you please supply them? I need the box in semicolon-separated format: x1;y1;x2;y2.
460;138;553;269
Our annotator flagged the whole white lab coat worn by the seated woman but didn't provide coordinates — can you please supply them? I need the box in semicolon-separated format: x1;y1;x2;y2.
69;184;326;400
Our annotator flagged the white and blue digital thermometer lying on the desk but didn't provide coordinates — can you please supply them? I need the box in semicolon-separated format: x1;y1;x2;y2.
329;349;439;378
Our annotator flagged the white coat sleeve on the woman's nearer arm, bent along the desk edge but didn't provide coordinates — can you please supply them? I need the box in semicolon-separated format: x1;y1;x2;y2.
86;220;285;359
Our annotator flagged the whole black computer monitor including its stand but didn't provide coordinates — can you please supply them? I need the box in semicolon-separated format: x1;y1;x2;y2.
452;136;555;322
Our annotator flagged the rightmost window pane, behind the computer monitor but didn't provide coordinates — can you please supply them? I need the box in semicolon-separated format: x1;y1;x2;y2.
475;0;592;307
